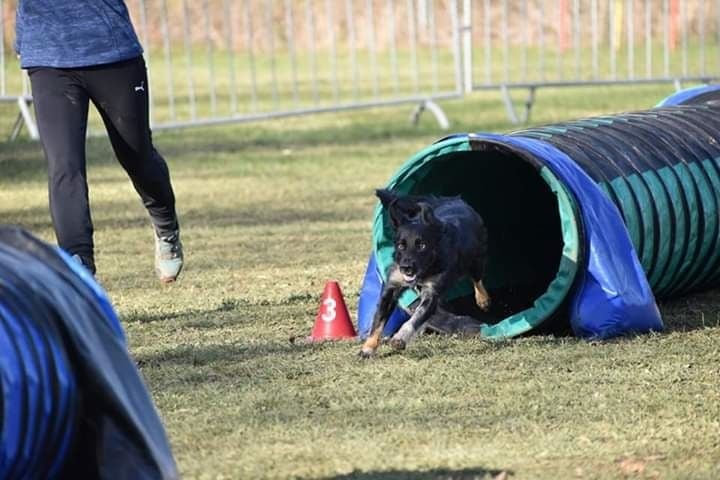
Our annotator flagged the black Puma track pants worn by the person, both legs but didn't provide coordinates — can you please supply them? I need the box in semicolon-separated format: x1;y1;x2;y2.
28;57;178;264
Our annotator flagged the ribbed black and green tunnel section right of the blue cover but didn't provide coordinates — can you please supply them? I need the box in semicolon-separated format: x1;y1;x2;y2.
512;103;720;298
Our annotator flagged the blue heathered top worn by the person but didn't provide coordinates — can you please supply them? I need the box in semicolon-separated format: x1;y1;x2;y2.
15;0;143;68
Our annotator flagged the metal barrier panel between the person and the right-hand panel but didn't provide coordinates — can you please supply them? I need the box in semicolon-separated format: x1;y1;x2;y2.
128;0;462;129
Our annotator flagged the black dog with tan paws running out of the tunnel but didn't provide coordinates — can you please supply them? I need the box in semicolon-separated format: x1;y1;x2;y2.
359;189;490;358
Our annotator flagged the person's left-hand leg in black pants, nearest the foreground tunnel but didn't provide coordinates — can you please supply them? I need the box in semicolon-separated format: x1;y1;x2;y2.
28;68;95;273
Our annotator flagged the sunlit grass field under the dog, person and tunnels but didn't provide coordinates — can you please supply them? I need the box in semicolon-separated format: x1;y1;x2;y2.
0;87;720;480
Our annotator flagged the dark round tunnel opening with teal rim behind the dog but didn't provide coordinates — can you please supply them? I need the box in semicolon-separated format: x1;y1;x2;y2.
375;141;580;337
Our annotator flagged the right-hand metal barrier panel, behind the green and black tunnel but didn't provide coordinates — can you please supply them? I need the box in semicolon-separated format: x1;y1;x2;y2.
461;0;720;123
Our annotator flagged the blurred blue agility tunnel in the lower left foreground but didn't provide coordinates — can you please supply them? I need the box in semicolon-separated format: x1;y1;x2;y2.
0;226;179;480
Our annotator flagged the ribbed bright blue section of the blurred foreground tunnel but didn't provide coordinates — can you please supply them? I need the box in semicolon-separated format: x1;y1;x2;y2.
0;276;78;478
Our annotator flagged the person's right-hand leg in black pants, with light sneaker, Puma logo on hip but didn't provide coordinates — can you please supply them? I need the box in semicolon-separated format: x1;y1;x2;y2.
83;57;183;282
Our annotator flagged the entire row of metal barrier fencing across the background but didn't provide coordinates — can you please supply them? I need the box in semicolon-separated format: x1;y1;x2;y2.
0;0;720;137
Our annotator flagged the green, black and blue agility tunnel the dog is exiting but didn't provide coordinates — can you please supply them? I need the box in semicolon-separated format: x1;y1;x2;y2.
358;85;720;339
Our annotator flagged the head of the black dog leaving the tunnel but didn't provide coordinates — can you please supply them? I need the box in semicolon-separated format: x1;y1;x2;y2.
378;188;443;285
